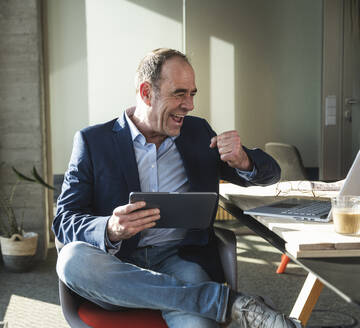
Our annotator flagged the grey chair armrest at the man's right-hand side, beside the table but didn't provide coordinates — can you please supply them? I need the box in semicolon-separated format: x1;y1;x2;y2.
214;227;237;290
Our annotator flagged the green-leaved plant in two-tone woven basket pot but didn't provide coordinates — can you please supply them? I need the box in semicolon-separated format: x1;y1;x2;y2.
0;166;54;272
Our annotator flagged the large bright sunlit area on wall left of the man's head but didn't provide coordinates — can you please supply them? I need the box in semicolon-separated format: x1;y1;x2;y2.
86;0;182;124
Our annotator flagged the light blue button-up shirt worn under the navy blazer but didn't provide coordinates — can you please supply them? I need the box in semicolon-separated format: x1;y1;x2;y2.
106;112;256;248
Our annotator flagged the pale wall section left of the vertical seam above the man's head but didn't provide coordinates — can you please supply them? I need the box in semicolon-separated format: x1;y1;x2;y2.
48;0;182;174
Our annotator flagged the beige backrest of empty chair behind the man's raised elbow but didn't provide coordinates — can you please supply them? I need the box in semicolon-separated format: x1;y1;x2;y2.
265;142;307;181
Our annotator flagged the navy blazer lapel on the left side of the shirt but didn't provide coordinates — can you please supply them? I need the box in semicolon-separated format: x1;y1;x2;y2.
113;114;141;192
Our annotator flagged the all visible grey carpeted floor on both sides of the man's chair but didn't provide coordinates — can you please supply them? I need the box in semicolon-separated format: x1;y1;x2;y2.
0;222;360;328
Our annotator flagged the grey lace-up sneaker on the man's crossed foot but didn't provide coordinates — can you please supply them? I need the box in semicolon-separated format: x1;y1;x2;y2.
231;295;302;328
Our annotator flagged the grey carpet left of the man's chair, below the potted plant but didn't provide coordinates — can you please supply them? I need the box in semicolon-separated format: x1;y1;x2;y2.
0;248;69;328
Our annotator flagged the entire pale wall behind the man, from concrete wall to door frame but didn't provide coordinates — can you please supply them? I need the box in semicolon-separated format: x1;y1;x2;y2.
48;0;322;174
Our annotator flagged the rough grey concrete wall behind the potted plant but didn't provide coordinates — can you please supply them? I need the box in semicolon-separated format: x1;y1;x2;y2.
0;0;48;258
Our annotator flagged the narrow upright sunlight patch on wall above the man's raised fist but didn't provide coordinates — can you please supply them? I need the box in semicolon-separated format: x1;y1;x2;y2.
210;36;235;134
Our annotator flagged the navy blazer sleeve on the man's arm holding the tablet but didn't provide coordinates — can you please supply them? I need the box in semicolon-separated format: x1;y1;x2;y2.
52;131;109;251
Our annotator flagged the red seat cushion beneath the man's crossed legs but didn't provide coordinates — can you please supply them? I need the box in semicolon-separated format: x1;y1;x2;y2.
78;302;168;328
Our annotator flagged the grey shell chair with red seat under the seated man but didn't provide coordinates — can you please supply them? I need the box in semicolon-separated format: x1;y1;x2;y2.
55;227;237;328
